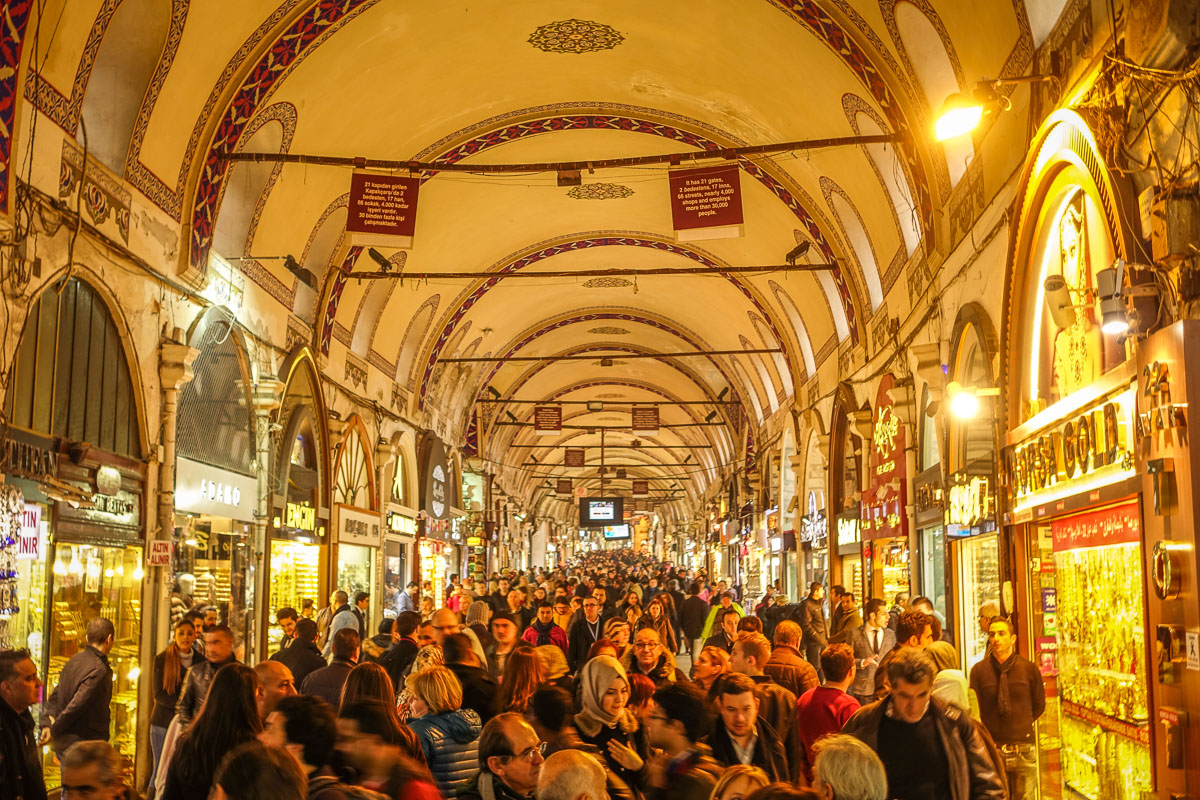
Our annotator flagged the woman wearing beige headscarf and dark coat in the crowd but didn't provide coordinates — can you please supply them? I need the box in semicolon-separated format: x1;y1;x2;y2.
575;656;650;794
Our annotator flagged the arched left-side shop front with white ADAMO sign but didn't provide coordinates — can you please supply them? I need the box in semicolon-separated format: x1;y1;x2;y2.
171;307;258;648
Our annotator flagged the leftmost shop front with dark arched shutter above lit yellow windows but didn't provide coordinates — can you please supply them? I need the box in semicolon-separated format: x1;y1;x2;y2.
0;277;146;787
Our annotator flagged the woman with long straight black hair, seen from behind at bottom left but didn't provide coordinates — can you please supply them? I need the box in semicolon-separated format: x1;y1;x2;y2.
162;663;263;800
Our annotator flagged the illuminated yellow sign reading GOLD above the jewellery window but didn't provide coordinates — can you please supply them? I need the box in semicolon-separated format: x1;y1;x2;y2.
1006;387;1134;511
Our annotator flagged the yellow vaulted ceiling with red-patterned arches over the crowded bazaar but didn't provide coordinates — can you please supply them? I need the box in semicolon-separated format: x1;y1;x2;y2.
28;0;1031;515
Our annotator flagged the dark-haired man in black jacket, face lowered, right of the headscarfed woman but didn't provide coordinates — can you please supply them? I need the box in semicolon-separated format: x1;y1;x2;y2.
708;673;791;783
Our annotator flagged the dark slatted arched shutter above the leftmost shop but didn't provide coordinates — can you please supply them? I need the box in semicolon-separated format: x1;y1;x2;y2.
4;278;142;458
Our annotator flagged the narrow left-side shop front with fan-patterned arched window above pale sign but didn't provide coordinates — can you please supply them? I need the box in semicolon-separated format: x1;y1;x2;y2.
334;416;383;631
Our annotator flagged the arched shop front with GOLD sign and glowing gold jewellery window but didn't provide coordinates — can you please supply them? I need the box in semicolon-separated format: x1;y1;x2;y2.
1003;110;1152;798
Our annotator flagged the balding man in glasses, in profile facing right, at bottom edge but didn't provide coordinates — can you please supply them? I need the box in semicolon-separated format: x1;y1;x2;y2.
458;714;546;800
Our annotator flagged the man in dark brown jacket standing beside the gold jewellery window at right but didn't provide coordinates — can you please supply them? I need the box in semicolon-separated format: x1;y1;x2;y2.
971;616;1046;800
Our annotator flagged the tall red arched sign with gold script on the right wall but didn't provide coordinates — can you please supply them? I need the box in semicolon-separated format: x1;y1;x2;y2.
862;375;908;541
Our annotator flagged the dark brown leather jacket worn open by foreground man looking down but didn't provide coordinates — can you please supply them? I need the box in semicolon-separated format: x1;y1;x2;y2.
841;697;1008;800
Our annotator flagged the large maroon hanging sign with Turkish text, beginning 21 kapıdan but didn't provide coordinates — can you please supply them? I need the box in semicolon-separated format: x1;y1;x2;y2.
346;172;421;247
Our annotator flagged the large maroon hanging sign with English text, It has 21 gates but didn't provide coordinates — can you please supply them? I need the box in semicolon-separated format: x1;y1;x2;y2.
668;164;743;241
